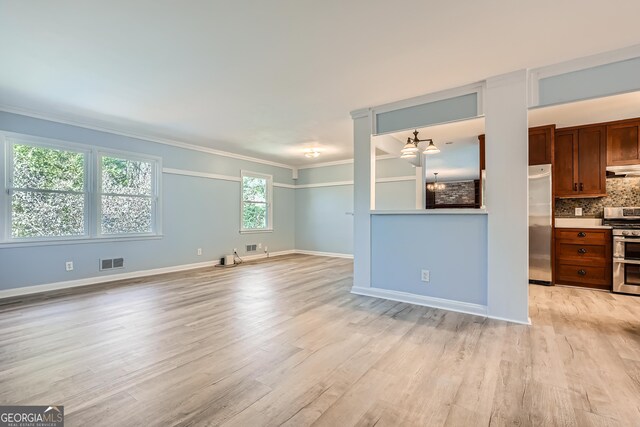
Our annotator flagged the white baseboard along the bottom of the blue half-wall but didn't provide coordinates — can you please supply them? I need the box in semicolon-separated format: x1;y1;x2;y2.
351;286;487;317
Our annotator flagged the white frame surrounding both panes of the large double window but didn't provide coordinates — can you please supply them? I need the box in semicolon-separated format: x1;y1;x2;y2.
0;132;162;247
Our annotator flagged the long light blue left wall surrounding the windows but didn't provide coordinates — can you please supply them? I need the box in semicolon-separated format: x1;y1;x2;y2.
0;112;295;292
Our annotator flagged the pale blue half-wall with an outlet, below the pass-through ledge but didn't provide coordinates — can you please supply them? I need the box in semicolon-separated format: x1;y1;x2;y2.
371;214;487;305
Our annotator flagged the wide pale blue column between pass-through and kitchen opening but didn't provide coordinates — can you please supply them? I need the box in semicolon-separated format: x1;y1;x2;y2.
484;70;529;323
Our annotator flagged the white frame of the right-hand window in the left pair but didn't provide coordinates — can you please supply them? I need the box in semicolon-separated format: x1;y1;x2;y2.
93;150;162;239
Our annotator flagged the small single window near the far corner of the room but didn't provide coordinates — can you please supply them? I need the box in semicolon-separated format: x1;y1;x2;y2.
240;171;273;232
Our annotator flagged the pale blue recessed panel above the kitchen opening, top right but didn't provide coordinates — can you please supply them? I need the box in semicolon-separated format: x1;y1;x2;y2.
538;58;640;106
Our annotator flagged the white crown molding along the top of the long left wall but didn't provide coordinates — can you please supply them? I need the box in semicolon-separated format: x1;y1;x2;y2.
0;104;294;169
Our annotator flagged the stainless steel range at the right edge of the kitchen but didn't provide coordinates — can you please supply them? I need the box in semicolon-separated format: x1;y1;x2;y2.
603;207;640;295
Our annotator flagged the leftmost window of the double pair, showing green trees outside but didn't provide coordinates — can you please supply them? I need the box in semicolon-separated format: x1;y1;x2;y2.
8;142;88;239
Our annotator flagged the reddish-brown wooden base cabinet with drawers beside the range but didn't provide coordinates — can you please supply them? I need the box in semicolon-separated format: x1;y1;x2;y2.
555;228;613;290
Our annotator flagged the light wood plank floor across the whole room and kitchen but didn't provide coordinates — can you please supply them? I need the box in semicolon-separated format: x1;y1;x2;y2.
0;255;640;427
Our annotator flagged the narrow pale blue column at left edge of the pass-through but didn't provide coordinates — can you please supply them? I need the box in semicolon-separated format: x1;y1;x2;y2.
351;109;376;288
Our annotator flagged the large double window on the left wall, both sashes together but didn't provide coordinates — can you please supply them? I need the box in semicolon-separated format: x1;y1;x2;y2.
0;133;161;243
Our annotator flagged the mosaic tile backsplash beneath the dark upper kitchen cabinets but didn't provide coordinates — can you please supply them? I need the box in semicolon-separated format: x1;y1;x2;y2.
556;177;640;218
